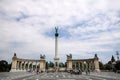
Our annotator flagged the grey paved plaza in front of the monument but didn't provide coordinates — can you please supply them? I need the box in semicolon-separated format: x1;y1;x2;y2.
0;72;120;80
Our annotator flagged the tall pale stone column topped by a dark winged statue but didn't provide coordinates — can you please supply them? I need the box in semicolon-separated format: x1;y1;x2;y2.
54;27;59;71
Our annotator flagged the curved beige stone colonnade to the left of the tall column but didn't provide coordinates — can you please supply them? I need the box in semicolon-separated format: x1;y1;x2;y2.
10;53;46;72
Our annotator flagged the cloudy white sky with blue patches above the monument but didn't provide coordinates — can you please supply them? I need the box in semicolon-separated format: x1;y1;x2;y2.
0;0;120;63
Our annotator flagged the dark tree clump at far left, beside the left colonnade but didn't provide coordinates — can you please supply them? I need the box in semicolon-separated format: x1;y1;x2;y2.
0;60;11;72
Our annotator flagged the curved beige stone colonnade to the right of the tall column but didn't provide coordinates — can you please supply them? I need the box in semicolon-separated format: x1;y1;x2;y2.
66;54;100;71
